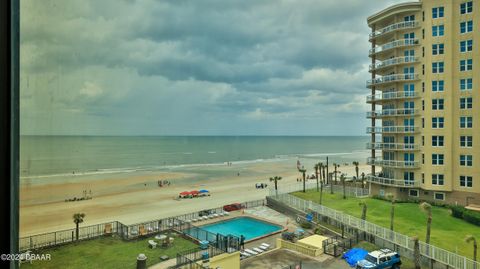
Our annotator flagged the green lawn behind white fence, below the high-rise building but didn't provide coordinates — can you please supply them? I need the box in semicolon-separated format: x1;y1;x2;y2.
293;190;480;258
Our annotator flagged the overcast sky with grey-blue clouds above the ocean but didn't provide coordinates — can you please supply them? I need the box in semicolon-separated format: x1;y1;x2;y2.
20;0;401;135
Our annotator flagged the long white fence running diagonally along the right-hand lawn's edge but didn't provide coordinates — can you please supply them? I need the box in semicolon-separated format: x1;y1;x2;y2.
269;194;480;269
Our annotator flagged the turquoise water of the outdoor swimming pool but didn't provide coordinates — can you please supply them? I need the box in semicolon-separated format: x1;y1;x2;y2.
200;217;283;240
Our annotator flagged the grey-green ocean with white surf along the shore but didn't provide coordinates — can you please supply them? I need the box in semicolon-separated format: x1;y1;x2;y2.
20;136;369;178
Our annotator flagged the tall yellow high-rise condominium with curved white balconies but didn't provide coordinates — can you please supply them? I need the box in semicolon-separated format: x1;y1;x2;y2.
367;0;480;205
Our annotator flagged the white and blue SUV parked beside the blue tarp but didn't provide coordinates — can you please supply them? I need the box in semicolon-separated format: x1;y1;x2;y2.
356;249;402;269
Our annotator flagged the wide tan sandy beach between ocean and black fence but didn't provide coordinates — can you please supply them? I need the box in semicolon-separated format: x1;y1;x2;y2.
20;160;369;237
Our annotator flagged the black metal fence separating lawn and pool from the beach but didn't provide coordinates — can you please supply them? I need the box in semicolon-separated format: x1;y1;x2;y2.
19;199;267;252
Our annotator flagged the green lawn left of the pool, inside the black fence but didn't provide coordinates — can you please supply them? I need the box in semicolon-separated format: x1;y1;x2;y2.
21;231;197;269
